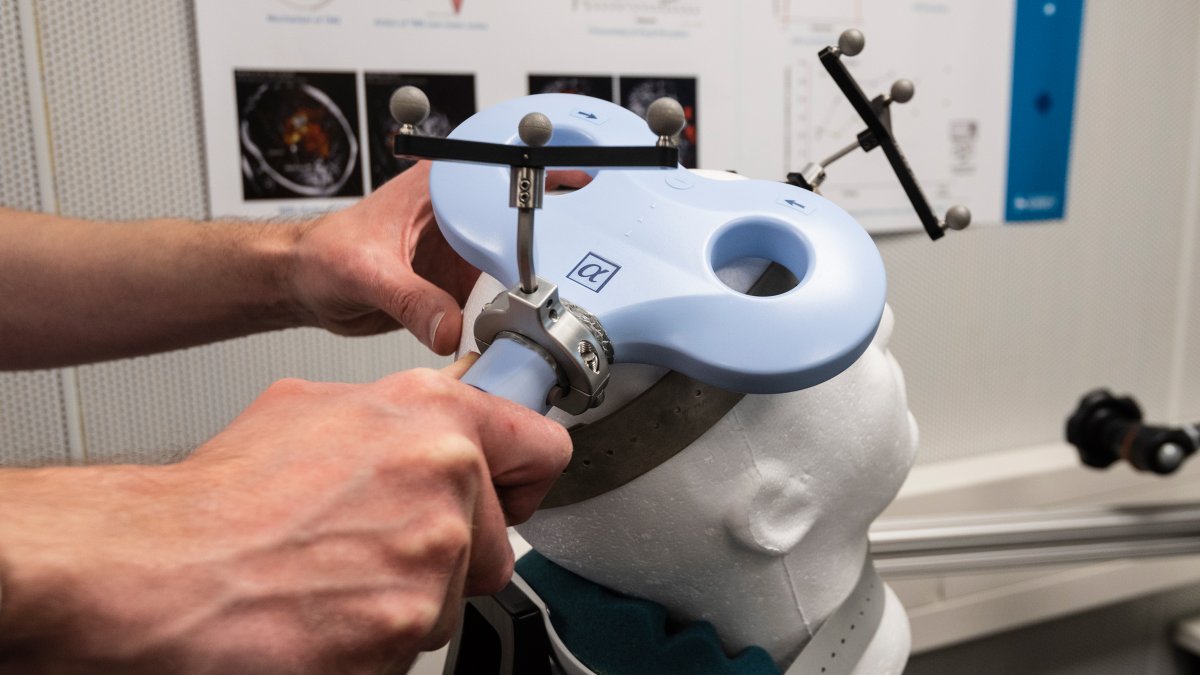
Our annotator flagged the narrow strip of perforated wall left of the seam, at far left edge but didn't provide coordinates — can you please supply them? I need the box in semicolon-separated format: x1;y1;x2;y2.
0;0;68;466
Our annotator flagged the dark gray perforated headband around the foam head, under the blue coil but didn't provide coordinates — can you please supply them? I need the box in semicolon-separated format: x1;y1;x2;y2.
541;263;796;508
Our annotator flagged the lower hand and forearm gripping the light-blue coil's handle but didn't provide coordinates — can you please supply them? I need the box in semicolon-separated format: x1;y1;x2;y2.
0;362;570;674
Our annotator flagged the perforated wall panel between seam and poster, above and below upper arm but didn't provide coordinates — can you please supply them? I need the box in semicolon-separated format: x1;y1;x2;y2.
37;0;443;462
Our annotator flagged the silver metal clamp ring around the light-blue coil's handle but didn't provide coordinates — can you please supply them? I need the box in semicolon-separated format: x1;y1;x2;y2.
475;277;613;414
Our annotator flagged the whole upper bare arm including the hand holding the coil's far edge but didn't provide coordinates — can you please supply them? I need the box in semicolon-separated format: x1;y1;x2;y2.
0;163;479;370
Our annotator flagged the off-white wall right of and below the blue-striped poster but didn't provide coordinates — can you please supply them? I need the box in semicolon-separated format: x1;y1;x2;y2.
878;1;1200;462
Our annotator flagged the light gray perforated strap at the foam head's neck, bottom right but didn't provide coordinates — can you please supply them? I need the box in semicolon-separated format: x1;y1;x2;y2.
785;555;887;675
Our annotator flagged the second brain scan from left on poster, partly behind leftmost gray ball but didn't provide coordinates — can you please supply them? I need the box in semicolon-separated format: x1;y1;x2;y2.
365;72;475;190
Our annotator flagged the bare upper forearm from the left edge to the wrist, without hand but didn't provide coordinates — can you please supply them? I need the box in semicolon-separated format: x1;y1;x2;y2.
0;209;304;370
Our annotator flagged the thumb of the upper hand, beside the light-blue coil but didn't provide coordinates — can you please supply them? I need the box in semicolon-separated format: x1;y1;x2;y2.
379;274;462;356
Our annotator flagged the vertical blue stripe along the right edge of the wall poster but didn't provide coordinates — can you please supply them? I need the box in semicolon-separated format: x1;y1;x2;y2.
1004;0;1084;222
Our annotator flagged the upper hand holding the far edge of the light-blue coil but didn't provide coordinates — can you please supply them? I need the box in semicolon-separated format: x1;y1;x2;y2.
290;162;590;354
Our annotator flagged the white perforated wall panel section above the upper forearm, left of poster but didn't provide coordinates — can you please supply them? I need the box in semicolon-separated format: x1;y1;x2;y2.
35;0;206;219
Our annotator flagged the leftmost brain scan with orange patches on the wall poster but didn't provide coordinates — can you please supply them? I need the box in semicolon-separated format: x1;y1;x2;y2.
234;71;362;201
